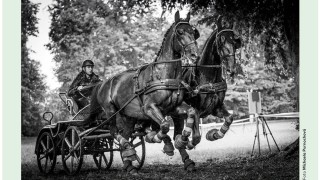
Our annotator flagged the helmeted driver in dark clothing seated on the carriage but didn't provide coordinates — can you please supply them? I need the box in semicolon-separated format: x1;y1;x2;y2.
68;60;101;109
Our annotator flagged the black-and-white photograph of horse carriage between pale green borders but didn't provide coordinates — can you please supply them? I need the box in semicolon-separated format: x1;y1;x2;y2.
17;0;309;180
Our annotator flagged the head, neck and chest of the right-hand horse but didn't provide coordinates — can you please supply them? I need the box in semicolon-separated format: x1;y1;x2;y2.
184;17;241;117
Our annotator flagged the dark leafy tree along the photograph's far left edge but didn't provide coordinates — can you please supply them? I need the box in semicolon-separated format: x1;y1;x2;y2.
21;0;45;136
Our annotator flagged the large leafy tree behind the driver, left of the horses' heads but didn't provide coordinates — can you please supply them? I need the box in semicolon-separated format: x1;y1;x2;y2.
47;0;169;90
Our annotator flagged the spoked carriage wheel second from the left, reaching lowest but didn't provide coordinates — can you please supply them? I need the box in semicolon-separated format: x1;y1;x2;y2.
61;126;83;175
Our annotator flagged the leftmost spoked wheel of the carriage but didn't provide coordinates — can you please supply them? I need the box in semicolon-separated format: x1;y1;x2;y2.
36;132;57;175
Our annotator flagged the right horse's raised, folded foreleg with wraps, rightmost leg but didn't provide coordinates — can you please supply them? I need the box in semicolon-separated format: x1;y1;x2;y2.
206;106;233;141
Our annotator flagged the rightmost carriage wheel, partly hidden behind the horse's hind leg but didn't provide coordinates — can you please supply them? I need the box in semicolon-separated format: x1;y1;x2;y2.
120;136;146;170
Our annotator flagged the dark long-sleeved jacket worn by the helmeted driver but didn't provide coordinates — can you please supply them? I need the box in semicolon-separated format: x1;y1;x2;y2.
68;71;101;97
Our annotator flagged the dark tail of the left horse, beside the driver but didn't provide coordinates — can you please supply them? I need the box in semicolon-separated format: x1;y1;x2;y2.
83;83;102;125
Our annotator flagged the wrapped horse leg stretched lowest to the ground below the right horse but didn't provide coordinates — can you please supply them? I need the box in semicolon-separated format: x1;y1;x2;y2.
173;116;195;171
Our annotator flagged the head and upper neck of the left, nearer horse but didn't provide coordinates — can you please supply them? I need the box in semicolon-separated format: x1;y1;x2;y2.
156;11;200;64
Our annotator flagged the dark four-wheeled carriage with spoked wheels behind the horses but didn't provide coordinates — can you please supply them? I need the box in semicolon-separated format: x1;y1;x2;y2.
35;88;145;175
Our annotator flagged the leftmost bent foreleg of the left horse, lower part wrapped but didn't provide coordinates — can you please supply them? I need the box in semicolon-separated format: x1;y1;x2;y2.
145;104;174;156
